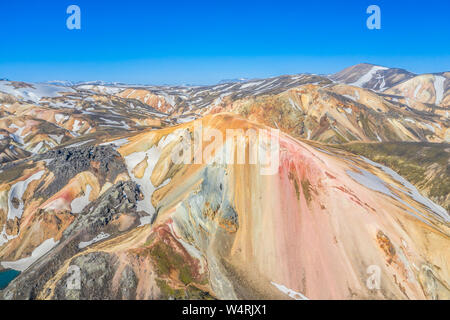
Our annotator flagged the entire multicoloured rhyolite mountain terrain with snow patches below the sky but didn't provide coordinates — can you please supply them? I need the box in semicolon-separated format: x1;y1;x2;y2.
0;65;450;299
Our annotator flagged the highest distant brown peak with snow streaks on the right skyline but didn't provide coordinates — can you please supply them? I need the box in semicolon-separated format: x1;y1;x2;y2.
330;63;415;91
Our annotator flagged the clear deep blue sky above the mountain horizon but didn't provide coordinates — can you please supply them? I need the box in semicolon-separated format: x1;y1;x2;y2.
0;0;450;84
